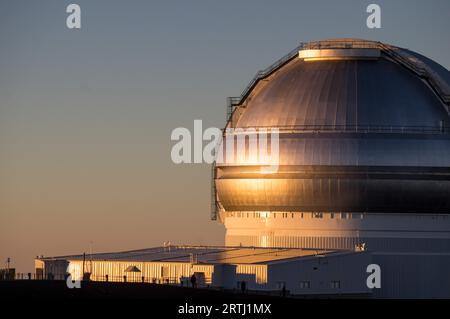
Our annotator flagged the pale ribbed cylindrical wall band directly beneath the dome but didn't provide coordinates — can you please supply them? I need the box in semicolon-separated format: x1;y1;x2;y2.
222;212;450;252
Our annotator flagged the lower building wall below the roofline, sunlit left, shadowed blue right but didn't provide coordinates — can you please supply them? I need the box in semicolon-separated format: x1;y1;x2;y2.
36;251;450;298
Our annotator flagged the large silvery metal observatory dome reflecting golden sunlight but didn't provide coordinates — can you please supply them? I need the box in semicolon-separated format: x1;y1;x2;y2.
213;39;450;218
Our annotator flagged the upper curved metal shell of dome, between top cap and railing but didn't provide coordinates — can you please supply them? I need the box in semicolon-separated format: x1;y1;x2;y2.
236;59;448;127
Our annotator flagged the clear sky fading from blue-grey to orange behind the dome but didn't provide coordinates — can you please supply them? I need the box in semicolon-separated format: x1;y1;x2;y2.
0;0;450;272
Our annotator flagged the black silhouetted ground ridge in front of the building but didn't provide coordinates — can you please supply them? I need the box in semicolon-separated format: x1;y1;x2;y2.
0;280;445;319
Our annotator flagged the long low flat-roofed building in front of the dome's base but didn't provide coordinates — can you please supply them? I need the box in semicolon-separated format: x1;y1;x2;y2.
35;246;372;297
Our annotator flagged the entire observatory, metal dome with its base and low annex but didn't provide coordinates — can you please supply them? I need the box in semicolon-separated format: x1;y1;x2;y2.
36;39;450;298
